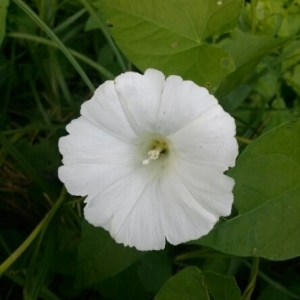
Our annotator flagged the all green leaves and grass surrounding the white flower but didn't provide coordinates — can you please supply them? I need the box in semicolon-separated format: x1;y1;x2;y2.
0;0;300;300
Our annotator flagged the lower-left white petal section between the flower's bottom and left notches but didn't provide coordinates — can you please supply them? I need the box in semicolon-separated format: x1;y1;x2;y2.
84;166;165;250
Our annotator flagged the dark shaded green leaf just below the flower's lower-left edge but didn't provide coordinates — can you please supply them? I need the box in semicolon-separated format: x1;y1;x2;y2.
76;220;144;287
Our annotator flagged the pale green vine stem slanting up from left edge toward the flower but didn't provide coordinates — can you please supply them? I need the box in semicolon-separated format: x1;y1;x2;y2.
0;188;66;276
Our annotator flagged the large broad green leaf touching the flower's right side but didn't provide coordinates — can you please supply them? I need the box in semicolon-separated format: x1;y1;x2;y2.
192;119;300;260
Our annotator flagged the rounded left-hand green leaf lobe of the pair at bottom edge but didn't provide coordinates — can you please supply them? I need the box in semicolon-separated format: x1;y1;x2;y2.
154;267;210;300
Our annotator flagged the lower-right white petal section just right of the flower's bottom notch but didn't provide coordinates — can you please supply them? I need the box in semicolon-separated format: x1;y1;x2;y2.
160;173;218;245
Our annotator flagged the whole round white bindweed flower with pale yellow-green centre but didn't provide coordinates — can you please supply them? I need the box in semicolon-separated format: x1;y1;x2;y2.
58;69;238;250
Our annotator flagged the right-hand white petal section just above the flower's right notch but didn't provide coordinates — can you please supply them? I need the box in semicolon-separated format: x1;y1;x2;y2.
168;105;238;171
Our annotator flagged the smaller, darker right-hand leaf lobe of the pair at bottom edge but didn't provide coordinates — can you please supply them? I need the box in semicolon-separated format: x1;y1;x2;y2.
203;271;241;300
